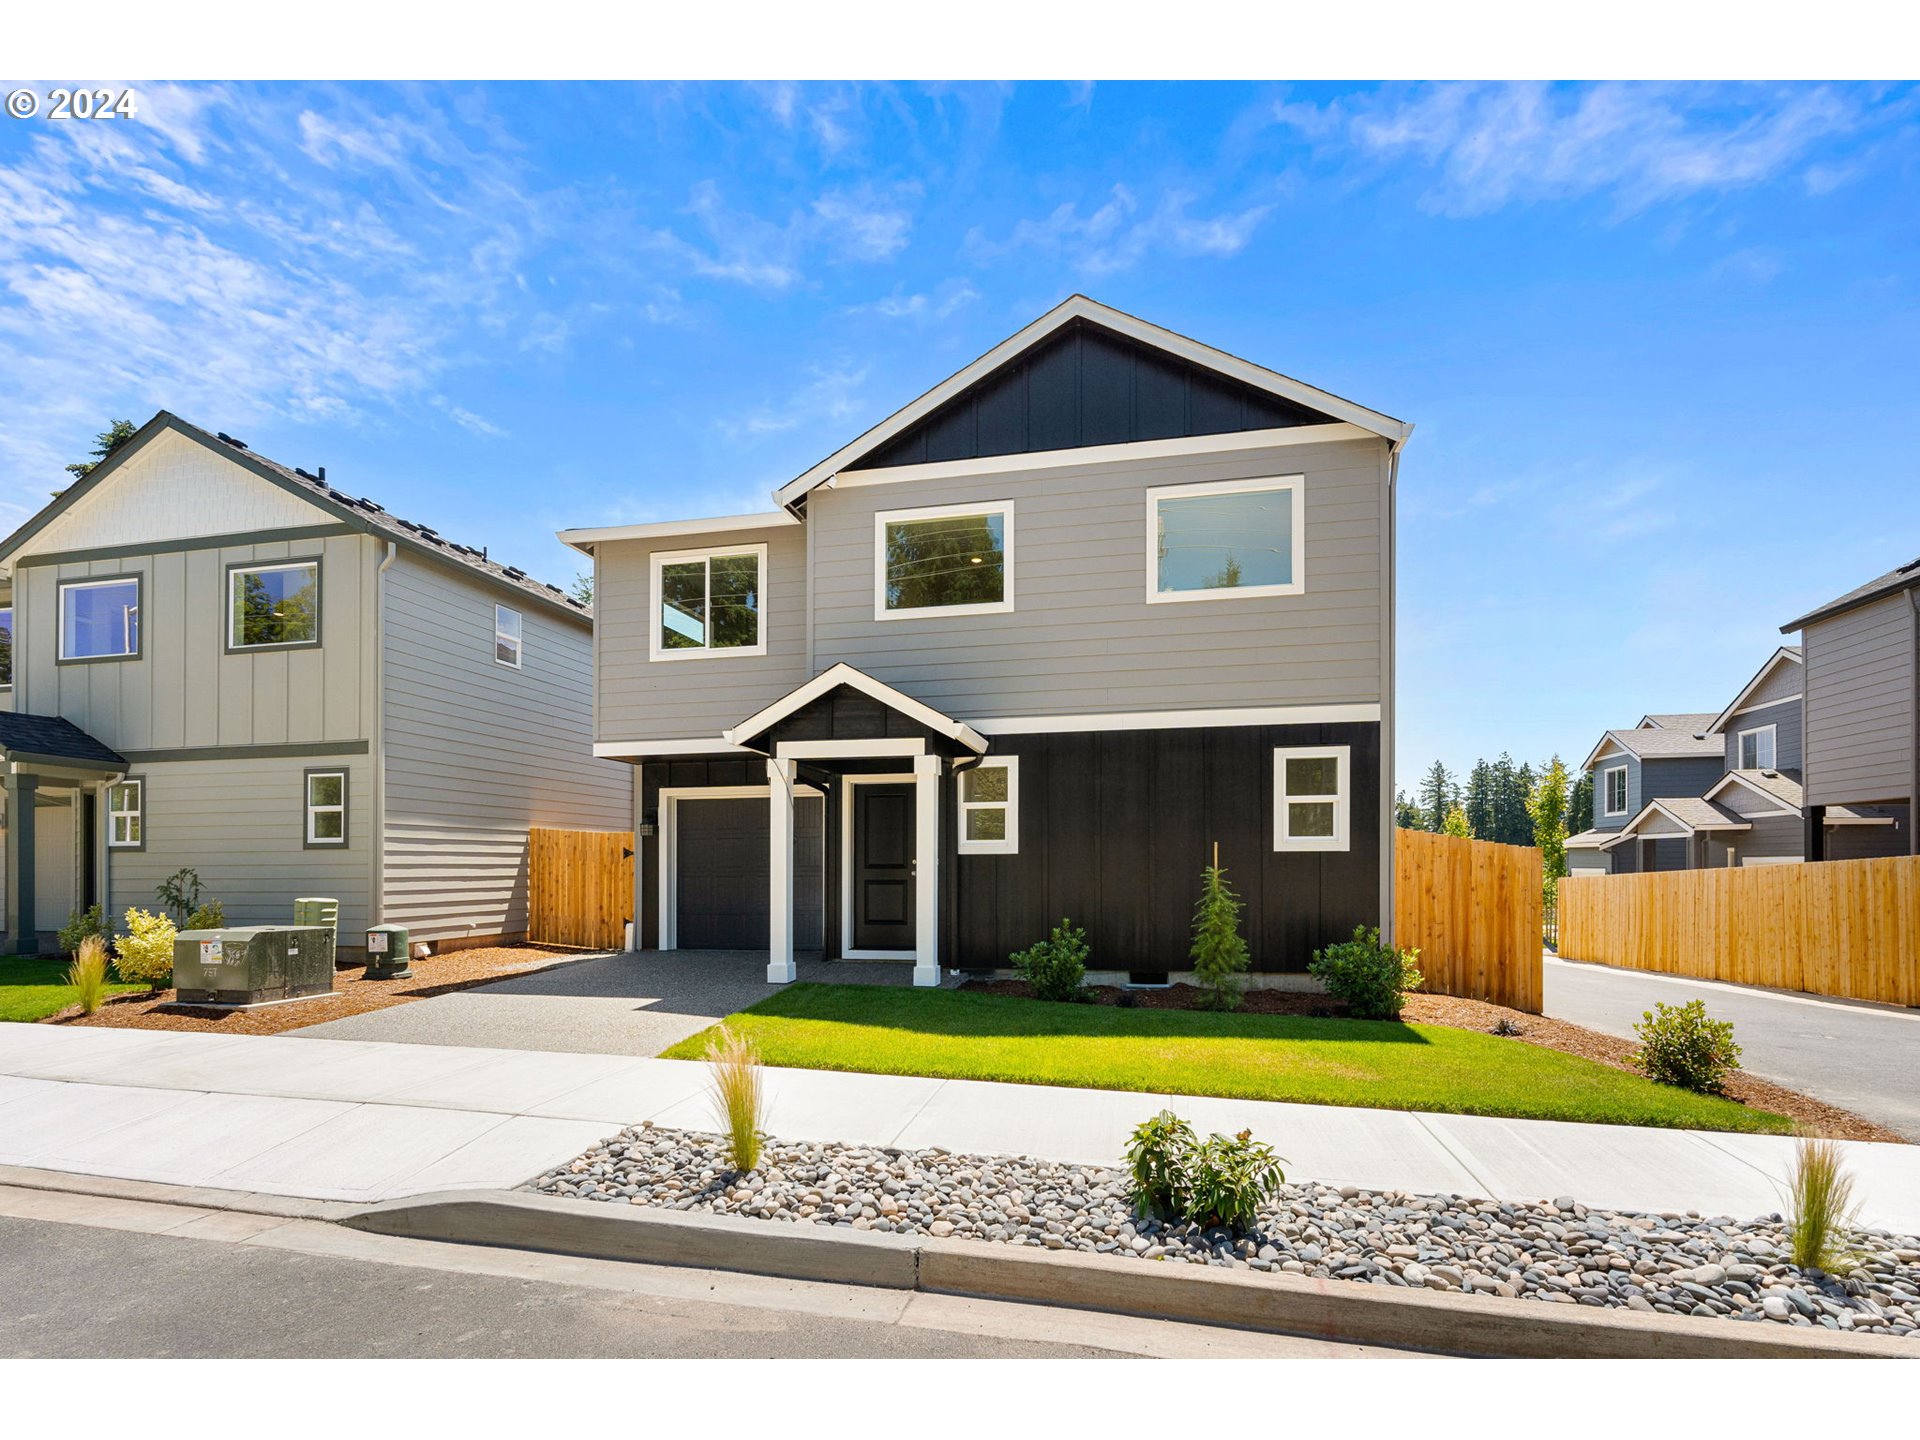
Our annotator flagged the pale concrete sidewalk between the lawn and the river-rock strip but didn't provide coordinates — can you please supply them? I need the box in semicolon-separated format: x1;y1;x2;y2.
0;1025;1920;1233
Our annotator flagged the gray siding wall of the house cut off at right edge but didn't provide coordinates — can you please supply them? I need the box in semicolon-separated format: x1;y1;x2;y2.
1803;591;1914;804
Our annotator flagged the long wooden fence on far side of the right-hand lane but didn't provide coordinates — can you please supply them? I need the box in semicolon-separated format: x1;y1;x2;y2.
1559;854;1920;1004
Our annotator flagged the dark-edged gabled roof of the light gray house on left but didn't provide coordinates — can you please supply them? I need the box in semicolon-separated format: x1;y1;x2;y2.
0;411;591;620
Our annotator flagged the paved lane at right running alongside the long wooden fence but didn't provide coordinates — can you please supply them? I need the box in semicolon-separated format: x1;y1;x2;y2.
1546;954;1920;1142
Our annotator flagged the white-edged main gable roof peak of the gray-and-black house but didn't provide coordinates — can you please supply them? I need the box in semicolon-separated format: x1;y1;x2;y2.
774;296;1413;507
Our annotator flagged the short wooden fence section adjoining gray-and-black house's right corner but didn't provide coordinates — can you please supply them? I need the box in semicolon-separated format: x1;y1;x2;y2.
1394;829;1565;1016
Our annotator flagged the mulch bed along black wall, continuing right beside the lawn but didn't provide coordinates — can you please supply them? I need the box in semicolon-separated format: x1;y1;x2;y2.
962;979;1907;1144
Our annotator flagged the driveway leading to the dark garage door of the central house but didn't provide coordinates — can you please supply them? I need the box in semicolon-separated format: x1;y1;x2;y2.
292;950;914;1056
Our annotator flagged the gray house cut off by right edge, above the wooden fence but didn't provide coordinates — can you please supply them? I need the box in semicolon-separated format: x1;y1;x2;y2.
1782;561;1920;860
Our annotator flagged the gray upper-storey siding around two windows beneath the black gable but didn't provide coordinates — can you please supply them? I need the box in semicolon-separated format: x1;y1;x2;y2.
808;440;1388;718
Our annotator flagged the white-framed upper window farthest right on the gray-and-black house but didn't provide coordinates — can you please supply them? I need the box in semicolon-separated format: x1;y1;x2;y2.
1146;474;1306;603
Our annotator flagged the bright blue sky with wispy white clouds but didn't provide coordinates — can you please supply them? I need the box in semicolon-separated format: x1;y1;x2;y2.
0;84;1920;780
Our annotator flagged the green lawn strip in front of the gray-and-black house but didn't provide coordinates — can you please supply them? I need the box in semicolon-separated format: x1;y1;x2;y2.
666;985;1791;1133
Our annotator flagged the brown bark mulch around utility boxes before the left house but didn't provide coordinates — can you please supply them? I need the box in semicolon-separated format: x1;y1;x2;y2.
40;945;599;1035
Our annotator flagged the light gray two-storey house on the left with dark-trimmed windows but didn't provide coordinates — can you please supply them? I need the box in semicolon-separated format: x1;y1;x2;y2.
0;411;632;952
